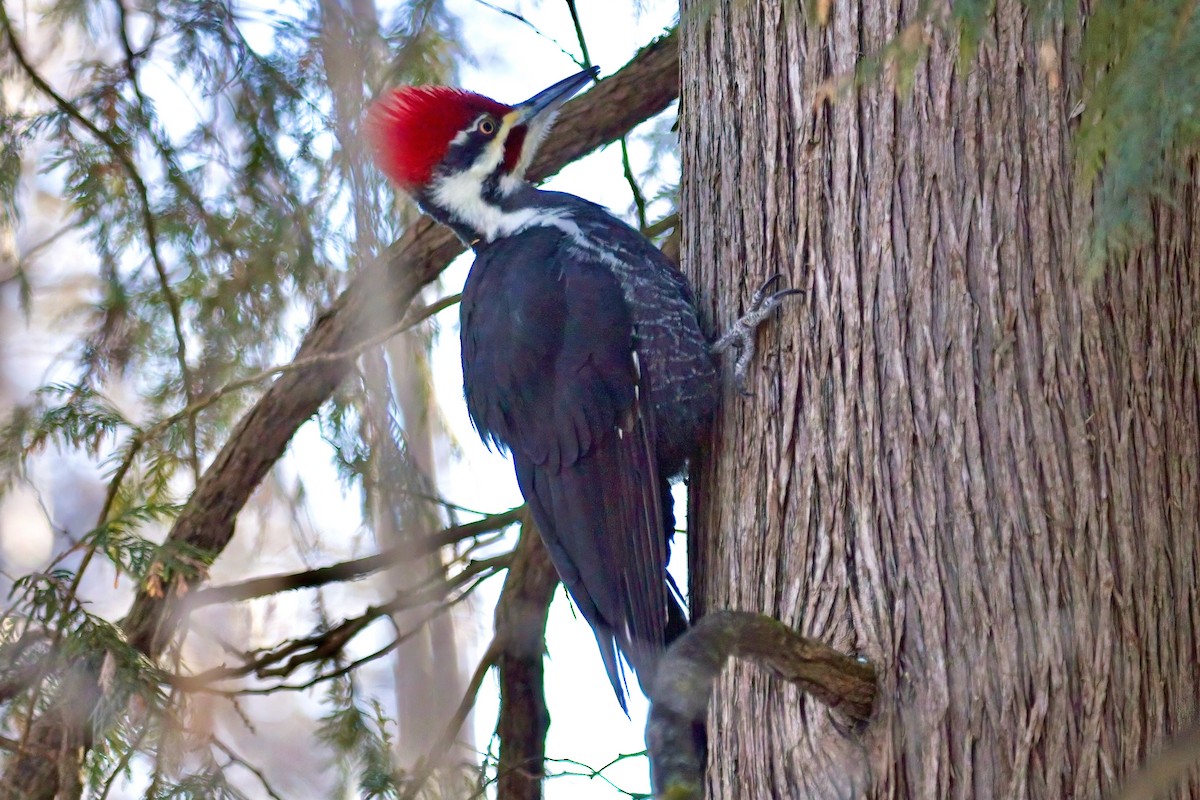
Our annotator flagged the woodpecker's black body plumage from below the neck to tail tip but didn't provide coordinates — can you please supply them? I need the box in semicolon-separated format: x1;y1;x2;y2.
462;187;718;702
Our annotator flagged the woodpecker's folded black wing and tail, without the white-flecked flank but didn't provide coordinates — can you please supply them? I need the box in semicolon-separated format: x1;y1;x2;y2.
462;229;667;708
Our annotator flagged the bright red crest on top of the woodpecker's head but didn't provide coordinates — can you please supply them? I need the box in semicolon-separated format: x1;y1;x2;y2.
367;86;512;191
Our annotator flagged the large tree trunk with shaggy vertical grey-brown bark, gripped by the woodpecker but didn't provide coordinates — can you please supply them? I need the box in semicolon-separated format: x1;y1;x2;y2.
680;0;1200;799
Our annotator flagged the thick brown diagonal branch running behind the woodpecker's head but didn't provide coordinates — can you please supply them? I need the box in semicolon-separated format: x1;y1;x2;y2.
0;36;679;800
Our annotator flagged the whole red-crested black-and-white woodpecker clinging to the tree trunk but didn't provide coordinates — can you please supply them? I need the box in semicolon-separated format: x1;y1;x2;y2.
370;67;790;708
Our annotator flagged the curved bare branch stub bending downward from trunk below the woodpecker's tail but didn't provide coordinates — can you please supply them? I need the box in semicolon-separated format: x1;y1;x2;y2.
646;610;876;800
